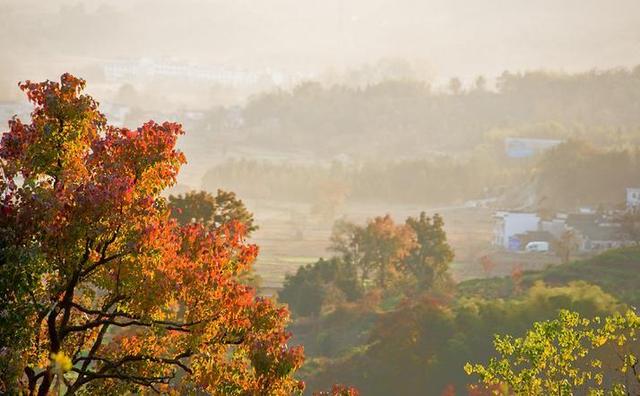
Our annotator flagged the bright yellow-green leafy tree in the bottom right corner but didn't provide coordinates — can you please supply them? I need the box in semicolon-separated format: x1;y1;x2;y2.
465;310;640;396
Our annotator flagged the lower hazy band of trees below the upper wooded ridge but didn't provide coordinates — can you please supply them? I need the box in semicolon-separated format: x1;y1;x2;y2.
202;139;640;211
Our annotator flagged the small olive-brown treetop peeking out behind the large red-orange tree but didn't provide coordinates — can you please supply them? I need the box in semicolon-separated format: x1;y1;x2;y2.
169;189;258;236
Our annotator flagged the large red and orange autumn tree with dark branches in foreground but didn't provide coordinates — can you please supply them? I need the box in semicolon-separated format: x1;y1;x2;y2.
0;74;304;395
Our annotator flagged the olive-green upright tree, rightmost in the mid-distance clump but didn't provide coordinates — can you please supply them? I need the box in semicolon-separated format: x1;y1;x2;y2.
400;212;453;288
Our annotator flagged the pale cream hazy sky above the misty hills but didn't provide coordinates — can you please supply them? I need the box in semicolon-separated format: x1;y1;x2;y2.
0;0;640;88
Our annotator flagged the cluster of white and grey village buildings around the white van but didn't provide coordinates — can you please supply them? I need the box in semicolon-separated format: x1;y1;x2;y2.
494;188;640;252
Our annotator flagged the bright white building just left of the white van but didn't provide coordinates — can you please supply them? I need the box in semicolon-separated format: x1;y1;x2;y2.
494;211;540;250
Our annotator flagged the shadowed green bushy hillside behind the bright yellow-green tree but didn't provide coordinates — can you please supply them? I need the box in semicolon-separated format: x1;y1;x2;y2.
291;243;640;395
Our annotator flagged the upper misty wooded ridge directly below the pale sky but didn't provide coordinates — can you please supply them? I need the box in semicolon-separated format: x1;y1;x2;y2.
198;67;640;159
